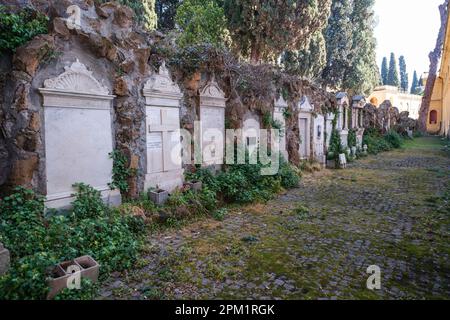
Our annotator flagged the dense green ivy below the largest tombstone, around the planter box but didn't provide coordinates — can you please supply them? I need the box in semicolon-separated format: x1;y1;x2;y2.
0;184;144;299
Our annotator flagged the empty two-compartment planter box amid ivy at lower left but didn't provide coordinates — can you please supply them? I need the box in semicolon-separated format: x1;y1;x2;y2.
47;256;100;300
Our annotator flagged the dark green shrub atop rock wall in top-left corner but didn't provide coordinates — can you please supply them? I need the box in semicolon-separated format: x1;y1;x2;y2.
0;5;48;53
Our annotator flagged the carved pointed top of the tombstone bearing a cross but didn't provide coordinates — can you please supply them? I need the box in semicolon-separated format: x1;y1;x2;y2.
143;63;183;107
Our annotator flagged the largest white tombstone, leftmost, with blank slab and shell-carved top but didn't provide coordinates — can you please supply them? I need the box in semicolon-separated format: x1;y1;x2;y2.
39;60;121;209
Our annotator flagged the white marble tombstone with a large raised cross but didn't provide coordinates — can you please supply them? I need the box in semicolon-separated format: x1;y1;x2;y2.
143;64;184;192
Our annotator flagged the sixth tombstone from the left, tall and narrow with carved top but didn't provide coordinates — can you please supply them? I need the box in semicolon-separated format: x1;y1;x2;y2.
298;96;314;159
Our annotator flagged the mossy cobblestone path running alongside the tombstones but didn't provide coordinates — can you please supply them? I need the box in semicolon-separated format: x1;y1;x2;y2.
100;138;450;299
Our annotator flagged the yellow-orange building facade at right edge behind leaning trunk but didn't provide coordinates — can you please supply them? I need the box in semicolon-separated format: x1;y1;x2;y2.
427;2;450;137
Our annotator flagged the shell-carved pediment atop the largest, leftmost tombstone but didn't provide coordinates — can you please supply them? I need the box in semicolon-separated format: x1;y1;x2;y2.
44;59;109;95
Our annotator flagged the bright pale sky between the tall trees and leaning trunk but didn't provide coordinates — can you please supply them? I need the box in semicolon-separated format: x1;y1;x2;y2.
375;0;444;83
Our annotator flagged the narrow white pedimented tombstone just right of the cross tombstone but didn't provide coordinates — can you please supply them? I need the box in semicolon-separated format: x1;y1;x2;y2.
200;78;226;166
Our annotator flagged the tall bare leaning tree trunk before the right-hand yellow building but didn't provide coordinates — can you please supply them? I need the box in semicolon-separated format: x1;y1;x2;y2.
419;0;449;132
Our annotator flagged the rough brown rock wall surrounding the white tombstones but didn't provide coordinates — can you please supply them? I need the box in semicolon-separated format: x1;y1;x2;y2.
0;0;336;197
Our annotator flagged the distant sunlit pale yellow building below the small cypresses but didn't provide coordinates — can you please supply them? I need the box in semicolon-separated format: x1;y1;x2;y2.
369;86;422;119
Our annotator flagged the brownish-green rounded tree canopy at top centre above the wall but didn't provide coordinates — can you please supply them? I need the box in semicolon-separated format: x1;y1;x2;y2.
223;0;331;63
